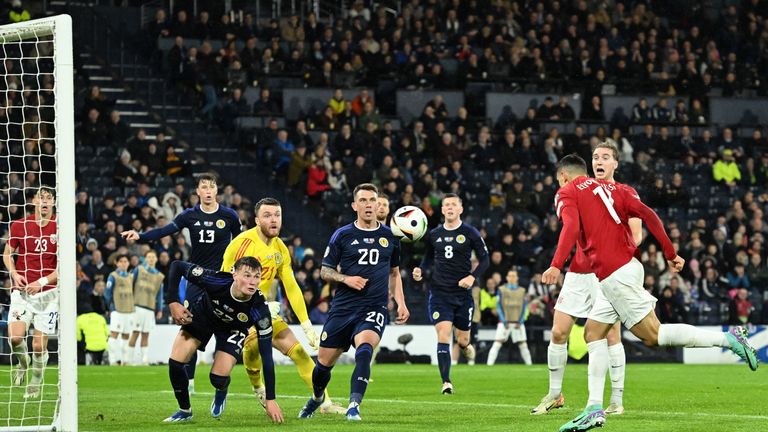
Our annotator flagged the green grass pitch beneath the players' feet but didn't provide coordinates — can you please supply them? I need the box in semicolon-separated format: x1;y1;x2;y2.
0;364;768;432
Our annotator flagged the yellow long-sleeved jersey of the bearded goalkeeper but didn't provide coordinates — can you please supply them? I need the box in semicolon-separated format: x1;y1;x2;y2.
221;227;309;322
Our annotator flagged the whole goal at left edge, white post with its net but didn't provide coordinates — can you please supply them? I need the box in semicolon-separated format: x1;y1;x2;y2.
0;15;77;431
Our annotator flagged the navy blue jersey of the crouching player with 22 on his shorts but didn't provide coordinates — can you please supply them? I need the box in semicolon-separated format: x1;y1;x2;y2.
169;261;272;339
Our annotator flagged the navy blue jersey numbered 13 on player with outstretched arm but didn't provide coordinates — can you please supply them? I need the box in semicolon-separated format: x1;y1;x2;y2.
140;204;241;269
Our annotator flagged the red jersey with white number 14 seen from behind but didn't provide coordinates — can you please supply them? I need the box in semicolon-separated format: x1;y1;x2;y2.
552;176;677;280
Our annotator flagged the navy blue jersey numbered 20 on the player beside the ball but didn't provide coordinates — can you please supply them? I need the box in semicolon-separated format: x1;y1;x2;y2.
323;223;400;311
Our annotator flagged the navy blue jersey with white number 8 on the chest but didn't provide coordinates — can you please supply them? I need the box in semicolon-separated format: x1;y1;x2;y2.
420;222;488;294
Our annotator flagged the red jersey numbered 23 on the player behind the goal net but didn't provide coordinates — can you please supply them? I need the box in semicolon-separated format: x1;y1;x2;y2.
8;215;58;291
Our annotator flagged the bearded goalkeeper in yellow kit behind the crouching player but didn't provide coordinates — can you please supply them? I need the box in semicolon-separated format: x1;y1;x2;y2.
221;198;346;414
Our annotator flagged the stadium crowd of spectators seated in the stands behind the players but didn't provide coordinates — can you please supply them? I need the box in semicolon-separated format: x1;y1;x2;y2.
0;0;768;364
